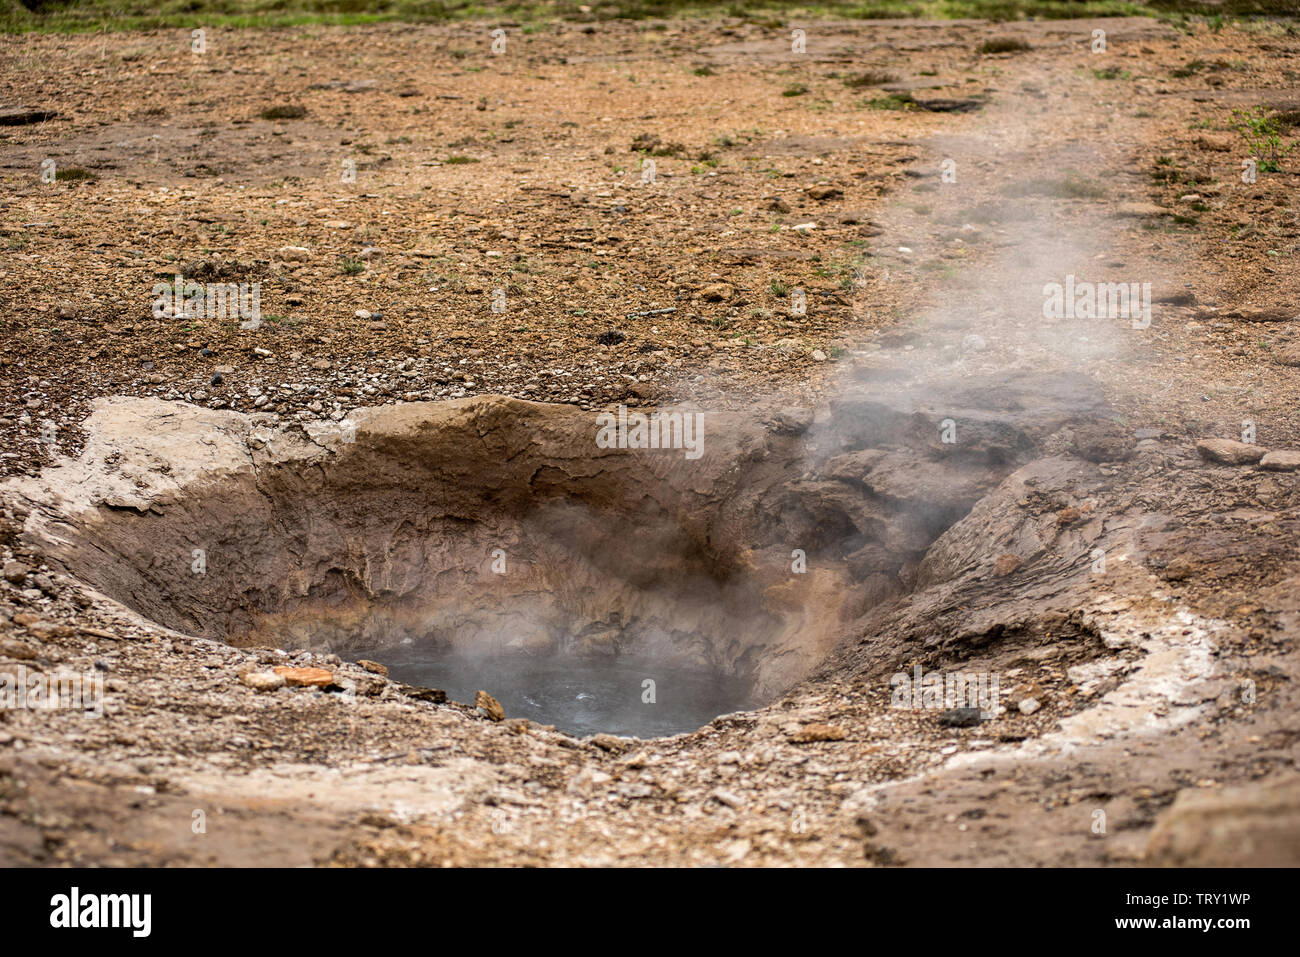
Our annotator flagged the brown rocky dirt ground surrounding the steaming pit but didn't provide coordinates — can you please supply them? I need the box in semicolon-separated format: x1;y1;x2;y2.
0;20;1300;866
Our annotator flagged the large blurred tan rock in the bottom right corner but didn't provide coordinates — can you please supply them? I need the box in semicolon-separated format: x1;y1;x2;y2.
1147;774;1300;867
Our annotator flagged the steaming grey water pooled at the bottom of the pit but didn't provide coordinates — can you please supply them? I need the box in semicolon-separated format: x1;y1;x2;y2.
373;644;754;737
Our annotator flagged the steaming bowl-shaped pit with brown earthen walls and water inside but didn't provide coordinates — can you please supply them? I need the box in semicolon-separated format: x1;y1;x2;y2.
10;377;1101;736
